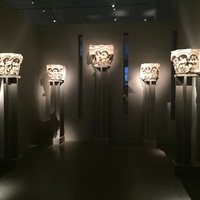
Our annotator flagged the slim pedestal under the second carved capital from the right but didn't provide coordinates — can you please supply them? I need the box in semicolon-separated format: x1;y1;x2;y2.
143;81;156;148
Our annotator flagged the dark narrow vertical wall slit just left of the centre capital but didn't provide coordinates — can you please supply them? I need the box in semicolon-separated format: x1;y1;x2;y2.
78;35;83;119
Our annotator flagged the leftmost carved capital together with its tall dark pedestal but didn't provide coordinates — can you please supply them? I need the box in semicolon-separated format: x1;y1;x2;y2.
0;53;23;166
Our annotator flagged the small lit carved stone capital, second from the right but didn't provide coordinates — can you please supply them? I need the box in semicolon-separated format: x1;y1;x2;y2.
140;63;160;81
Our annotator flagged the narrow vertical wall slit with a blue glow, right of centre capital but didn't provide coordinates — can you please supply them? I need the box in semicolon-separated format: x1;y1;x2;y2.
123;33;129;119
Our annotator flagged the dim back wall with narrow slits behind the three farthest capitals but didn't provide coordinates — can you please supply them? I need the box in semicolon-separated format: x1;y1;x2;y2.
40;22;176;143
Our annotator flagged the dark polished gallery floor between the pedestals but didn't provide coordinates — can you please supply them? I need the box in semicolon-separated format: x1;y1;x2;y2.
0;142;191;200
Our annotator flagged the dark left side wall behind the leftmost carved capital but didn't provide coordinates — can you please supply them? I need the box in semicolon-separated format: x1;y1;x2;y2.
0;1;39;155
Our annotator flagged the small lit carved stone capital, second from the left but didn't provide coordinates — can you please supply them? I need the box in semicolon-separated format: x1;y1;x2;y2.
46;64;65;81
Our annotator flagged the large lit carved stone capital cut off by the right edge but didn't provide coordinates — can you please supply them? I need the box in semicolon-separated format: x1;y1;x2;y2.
171;49;200;74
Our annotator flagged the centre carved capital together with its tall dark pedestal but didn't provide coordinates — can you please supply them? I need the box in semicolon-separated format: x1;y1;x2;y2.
89;45;114;144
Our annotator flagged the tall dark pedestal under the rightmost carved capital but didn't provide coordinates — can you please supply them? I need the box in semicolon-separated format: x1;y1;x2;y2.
175;74;200;175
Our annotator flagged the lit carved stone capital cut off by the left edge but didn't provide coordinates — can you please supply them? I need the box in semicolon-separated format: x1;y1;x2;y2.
0;53;23;76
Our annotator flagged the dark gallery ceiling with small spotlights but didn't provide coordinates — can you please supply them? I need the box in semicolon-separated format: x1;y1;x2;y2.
2;0;178;25
